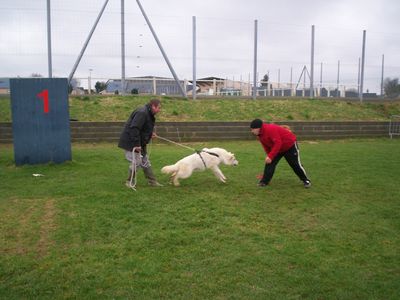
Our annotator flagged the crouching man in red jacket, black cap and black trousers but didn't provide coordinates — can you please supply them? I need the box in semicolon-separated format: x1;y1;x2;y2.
250;119;311;188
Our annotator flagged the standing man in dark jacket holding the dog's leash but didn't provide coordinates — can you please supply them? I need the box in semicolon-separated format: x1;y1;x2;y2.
118;99;162;187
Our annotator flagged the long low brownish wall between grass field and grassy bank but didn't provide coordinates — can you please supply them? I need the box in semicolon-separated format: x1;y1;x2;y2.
0;121;389;144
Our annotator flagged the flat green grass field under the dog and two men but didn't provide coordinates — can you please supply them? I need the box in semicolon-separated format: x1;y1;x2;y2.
0;139;400;299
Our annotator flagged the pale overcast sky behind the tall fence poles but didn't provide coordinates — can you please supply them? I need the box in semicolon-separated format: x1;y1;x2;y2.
0;0;400;93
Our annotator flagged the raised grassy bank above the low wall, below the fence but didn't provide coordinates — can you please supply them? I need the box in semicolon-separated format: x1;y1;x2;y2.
0;96;400;122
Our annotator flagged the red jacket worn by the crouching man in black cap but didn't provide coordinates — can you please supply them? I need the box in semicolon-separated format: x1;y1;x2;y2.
257;123;296;160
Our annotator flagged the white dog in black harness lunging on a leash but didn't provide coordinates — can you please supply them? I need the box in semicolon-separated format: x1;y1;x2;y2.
161;148;239;186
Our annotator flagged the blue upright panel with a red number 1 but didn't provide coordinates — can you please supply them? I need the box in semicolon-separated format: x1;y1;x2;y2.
10;78;71;166
